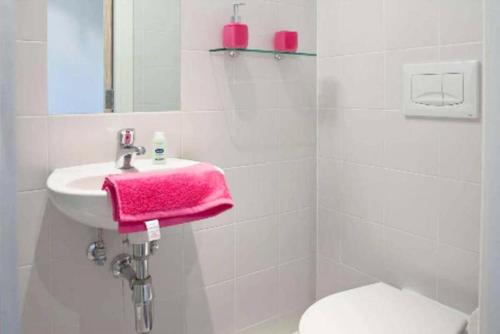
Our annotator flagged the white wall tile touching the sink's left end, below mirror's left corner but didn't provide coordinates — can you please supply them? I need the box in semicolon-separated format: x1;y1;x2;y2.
16;117;48;191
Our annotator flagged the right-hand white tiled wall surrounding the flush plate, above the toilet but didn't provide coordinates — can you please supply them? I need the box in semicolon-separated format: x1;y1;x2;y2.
317;0;483;312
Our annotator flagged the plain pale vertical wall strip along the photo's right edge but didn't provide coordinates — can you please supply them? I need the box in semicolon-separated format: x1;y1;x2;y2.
480;0;500;334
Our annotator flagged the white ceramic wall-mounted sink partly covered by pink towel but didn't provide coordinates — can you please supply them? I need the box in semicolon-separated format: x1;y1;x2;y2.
47;159;198;230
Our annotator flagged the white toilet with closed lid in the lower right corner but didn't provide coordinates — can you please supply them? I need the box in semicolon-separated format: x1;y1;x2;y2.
299;283;477;334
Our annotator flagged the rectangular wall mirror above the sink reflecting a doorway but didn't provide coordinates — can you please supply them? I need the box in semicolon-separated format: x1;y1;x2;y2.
47;0;181;115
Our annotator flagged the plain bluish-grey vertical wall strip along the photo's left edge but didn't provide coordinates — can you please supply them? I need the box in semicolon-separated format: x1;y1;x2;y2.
0;0;19;334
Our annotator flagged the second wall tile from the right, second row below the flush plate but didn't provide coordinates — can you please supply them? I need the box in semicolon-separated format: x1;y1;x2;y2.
384;171;440;240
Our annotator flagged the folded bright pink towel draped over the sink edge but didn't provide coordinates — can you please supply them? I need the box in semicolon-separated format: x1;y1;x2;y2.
102;163;233;233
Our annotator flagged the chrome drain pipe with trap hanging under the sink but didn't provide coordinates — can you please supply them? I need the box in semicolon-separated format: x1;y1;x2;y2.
111;241;159;334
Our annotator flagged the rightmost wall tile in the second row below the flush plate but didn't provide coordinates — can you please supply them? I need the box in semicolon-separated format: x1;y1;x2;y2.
439;180;481;252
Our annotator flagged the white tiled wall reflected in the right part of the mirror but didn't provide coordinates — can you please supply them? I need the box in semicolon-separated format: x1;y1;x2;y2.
130;0;181;111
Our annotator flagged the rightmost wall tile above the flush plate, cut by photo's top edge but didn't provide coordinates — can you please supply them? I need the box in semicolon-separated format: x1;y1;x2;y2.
439;0;483;44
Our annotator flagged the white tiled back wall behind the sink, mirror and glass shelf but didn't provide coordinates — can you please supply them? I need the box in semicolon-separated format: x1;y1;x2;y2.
16;0;316;334
